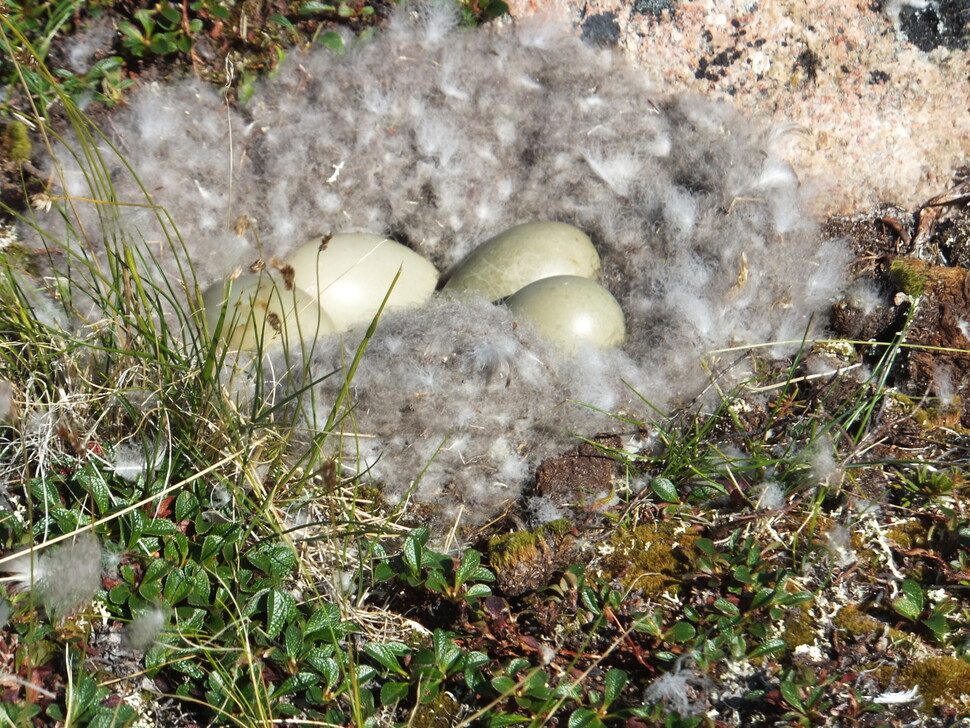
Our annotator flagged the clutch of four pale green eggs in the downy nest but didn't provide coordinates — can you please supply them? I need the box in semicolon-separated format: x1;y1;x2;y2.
203;221;626;351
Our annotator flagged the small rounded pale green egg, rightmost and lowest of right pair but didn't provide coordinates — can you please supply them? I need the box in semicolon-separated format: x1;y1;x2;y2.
505;276;626;351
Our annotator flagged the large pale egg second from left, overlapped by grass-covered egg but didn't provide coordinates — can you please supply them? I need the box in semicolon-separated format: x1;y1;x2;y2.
288;233;438;331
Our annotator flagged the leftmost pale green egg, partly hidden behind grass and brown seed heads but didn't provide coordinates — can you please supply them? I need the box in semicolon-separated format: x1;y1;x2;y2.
202;275;336;351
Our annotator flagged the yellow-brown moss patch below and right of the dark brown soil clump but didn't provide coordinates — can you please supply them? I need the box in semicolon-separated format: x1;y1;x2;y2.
601;522;699;596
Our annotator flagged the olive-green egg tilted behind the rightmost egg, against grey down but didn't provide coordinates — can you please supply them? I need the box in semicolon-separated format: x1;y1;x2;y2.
445;222;600;301
